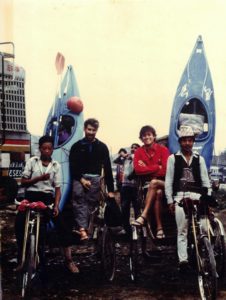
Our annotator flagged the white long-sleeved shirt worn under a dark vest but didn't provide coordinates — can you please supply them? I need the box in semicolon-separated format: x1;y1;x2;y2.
165;151;210;204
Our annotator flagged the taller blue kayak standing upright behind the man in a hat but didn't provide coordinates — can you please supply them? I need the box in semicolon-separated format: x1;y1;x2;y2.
168;36;216;169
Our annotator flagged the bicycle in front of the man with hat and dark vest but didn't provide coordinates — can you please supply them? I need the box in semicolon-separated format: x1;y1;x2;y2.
178;198;218;300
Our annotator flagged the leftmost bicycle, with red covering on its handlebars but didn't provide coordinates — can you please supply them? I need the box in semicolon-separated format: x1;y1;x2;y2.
15;200;52;298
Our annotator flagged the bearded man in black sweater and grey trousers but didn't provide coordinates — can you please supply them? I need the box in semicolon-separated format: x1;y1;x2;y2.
69;119;114;240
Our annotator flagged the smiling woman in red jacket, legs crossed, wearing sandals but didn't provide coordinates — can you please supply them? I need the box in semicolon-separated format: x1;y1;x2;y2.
132;125;169;239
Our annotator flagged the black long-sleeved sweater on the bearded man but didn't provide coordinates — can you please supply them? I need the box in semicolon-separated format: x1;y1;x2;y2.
69;138;114;192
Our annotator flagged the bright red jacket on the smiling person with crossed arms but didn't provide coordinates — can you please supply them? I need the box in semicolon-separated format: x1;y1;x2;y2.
134;143;170;177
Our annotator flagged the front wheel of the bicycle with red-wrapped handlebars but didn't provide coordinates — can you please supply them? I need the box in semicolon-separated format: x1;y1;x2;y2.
22;234;35;299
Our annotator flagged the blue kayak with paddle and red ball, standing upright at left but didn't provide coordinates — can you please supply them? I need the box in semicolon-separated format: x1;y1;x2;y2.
44;66;84;210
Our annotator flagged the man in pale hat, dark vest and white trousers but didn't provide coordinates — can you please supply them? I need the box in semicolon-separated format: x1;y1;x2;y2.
165;126;210;270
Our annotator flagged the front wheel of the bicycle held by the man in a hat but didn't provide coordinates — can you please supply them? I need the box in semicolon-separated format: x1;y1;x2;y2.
197;237;217;300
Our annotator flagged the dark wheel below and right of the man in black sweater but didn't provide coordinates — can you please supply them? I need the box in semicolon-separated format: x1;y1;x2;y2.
101;225;116;281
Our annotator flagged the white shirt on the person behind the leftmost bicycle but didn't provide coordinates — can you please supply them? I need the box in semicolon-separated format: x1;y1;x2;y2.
22;156;61;194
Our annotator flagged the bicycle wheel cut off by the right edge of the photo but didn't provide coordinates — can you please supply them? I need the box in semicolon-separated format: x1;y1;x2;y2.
212;220;225;278
